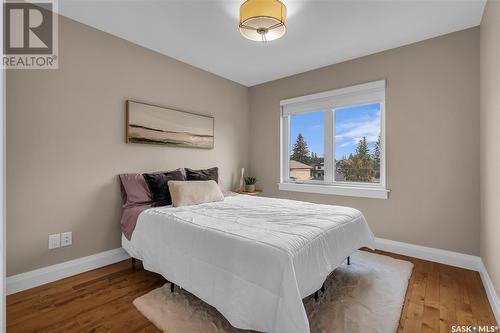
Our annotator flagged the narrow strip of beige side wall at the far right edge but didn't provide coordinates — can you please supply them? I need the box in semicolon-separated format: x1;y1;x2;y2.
480;0;500;304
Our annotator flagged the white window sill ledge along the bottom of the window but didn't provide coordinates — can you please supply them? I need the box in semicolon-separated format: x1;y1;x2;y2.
278;183;389;199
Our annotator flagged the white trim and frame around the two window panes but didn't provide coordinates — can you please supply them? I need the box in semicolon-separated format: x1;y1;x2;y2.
278;80;390;199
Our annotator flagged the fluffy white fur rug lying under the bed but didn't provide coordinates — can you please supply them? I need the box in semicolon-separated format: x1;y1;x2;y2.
134;251;413;333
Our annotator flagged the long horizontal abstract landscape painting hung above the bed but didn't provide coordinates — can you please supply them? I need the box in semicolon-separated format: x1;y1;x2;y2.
127;100;214;149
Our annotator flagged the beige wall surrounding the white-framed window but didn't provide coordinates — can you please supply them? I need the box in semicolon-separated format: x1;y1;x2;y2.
249;28;478;255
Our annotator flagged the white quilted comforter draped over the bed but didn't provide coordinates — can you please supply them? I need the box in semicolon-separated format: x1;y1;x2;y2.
123;195;374;332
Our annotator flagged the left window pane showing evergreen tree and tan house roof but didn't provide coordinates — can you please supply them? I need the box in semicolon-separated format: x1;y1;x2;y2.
290;112;325;180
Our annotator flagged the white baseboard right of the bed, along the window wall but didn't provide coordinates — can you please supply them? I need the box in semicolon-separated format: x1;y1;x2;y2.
375;238;481;271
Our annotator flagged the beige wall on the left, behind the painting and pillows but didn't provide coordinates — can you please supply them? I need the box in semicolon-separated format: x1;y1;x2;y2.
7;17;248;275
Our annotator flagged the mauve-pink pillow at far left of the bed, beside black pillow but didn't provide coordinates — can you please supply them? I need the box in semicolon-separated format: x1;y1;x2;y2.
120;173;152;207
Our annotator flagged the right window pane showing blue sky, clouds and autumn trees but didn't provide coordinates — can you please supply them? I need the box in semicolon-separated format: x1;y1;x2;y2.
334;103;381;183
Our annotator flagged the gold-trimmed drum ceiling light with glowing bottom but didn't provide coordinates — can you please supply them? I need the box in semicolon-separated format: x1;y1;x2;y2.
240;0;286;42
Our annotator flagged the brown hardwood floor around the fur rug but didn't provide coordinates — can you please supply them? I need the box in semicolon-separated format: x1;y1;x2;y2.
7;251;496;333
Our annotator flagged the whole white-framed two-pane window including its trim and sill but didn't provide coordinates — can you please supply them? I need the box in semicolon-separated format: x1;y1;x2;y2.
279;81;388;199
